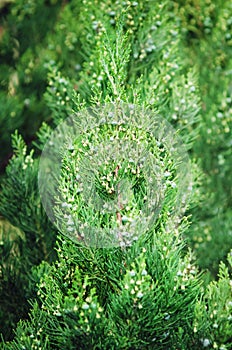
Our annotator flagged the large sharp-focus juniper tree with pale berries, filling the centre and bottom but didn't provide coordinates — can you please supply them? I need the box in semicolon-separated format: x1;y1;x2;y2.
0;1;231;349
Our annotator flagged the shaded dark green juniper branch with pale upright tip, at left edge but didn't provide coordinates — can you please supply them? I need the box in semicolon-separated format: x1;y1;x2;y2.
0;132;51;247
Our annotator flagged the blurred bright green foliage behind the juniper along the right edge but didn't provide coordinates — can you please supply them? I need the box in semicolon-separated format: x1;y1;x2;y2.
176;0;232;278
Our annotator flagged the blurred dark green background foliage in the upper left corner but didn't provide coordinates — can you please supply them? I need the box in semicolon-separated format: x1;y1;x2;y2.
0;0;82;171
